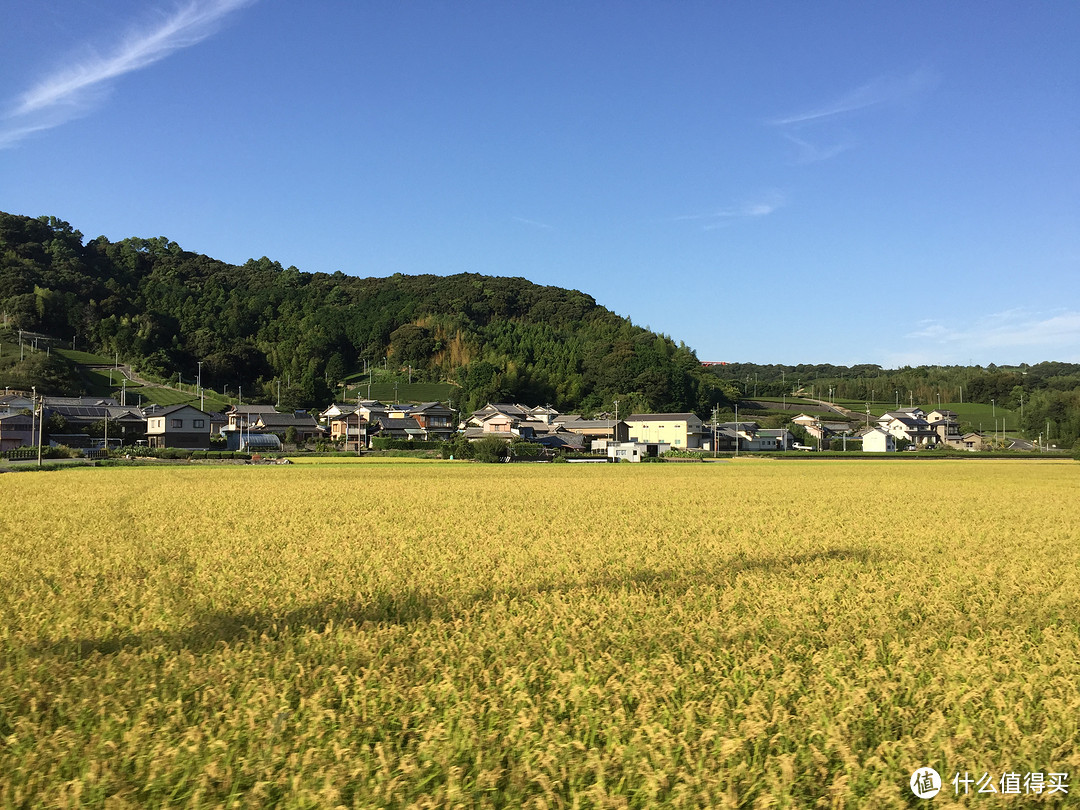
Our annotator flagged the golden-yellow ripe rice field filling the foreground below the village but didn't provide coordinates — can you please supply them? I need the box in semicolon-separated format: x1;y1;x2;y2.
0;460;1080;808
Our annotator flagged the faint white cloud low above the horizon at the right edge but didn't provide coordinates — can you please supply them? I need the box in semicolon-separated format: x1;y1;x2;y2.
905;309;1080;363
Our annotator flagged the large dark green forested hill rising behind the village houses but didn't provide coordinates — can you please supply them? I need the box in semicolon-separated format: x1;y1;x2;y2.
0;213;728;414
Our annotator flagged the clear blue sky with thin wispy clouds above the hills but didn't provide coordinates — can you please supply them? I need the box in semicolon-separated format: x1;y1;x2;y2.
0;0;1080;367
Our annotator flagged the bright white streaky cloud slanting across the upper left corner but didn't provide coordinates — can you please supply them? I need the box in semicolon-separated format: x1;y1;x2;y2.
0;0;255;147
